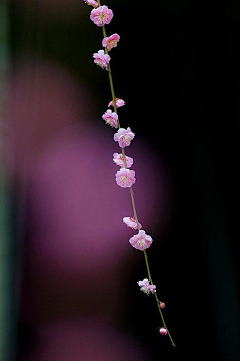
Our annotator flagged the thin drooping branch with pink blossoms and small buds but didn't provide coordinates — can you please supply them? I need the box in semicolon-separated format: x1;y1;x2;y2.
84;0;175;346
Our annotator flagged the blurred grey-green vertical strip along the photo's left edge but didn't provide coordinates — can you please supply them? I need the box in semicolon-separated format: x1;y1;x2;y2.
0;0;15;361
